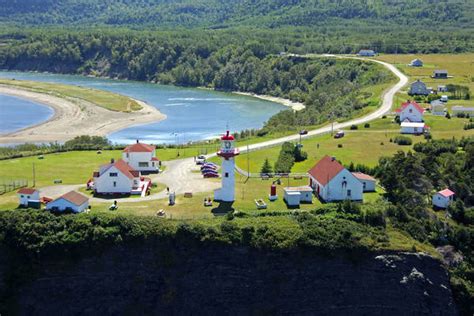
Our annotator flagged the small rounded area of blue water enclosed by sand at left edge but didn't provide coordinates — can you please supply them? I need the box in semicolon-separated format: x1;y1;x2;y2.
0;94;54;134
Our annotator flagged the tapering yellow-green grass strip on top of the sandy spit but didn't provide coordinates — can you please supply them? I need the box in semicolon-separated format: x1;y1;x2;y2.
0;79;142;112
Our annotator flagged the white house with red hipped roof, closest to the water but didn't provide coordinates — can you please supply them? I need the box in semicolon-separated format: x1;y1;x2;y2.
122;140;160;173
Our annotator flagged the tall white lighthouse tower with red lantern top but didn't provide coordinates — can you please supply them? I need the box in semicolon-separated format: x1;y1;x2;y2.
214;131;239;202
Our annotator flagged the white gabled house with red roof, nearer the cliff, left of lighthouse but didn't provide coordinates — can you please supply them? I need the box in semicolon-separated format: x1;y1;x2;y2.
92;159;151;195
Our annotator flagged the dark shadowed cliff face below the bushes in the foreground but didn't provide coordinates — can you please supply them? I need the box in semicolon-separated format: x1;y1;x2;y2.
0;244;456;315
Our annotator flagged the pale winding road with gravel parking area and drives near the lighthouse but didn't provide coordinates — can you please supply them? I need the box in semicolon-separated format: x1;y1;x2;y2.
41;55;408;203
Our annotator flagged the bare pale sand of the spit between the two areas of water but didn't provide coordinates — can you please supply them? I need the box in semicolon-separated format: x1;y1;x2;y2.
0;85;166;144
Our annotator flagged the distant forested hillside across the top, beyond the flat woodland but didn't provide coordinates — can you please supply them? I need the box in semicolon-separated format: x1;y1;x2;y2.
0;0;474;28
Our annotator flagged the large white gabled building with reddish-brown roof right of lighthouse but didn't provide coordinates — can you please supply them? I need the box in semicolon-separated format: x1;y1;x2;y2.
308;156;363;202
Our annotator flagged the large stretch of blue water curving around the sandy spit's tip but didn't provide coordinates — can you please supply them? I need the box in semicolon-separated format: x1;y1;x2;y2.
0;71;285;143
